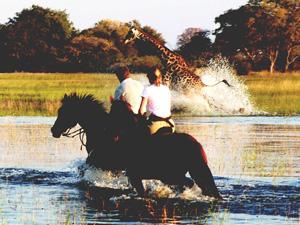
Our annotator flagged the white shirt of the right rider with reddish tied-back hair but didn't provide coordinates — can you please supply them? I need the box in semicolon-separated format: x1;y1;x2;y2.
142;84;171;118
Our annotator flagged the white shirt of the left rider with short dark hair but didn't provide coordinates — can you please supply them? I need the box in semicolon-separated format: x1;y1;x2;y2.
114;77;144;114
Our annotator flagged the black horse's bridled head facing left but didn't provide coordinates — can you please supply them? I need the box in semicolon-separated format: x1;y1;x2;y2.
51;94;78;138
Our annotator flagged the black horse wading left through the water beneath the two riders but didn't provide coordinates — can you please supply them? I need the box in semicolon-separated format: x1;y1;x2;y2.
51;94;222;199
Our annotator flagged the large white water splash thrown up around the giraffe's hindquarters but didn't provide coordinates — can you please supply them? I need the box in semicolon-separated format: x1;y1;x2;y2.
172;58;259;115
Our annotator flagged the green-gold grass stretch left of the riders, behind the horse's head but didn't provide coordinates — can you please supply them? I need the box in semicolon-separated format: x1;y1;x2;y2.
0;73;118;116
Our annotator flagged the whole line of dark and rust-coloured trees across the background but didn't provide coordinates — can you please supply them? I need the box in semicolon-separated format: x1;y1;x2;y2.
0;0;300;74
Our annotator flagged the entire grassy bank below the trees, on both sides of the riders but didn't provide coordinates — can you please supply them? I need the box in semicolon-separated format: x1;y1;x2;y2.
0;73;300;116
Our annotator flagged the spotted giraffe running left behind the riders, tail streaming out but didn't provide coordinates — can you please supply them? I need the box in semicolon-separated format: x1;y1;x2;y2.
125;26;230;92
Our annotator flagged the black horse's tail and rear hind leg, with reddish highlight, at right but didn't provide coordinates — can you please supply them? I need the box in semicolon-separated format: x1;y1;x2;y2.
189;142;222;199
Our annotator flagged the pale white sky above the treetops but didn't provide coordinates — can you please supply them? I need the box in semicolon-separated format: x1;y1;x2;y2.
0;0;248;49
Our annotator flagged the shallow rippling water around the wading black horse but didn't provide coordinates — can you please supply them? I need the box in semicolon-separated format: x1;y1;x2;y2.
0;117;300;224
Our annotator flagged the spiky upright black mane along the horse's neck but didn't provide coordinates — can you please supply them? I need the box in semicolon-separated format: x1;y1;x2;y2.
61;92;106;113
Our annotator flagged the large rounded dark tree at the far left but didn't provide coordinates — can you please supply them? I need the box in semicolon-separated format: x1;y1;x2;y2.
5;5;75;71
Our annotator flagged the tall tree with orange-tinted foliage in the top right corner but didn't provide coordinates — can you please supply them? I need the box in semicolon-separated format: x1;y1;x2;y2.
215;0;299;73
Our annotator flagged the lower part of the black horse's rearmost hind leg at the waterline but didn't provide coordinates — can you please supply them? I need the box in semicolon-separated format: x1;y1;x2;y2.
189;162;222;199
